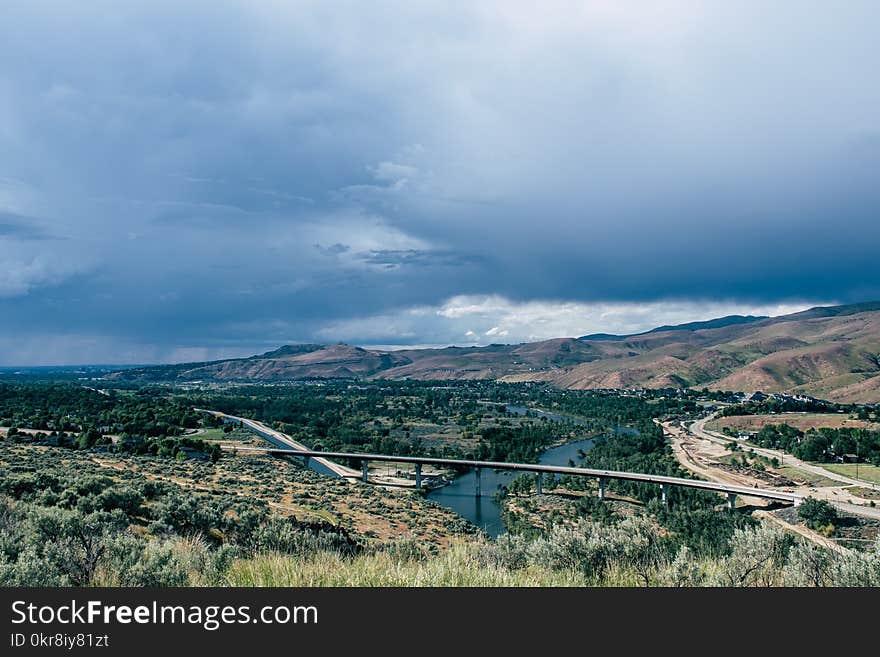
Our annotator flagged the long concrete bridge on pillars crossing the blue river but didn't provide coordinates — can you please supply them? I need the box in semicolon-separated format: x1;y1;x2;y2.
224;445;803;509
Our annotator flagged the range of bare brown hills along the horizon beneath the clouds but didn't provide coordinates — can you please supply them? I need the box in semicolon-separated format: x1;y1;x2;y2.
110;302;880;402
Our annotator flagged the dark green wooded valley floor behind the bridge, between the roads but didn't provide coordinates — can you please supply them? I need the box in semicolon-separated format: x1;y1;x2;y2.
193;381;696;462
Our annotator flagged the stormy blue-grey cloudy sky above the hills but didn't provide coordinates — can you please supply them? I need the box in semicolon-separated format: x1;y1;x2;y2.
0;0;880;365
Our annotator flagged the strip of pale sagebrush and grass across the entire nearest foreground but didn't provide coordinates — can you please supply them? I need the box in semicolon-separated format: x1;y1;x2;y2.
0;486;880;586
